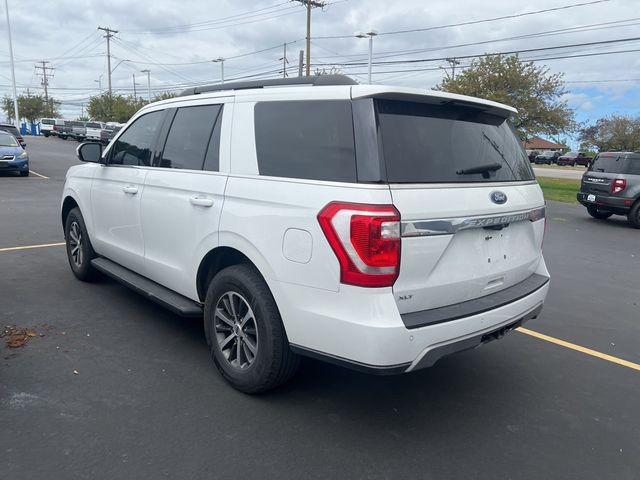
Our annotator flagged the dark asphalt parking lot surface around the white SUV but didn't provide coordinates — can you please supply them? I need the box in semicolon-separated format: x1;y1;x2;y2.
0;137;640;480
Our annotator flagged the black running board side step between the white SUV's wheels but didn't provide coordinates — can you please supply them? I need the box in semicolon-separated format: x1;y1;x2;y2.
91;258;202;317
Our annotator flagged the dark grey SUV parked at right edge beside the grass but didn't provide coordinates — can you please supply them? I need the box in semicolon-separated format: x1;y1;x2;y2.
578;152;640;228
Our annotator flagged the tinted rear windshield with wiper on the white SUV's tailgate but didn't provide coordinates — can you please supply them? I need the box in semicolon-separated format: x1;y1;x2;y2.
376;100;534;183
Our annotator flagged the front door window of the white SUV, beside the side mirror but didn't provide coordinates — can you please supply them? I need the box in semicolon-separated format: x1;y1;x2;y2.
109;110;164;166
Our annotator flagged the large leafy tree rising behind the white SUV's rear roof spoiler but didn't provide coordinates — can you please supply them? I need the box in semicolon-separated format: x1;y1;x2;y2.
435;55;578;139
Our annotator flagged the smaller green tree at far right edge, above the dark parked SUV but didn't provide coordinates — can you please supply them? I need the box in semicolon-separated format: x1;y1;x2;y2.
579;115;640;152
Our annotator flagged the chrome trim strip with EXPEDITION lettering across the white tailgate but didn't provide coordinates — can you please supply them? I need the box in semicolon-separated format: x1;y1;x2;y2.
401;207;546;238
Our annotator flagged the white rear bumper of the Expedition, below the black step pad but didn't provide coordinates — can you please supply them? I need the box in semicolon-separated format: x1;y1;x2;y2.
276;261;549;375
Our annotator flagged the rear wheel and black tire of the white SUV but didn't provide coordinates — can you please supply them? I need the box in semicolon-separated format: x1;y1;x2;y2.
204;264;299;393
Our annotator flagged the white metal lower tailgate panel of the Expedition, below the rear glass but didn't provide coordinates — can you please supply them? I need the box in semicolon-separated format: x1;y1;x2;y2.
391;183;544;313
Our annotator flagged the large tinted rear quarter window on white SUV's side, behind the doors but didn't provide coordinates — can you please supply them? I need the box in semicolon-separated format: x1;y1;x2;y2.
255;100;356;182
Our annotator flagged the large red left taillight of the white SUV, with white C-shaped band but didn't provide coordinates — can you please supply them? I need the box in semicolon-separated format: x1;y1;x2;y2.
318;202;400;287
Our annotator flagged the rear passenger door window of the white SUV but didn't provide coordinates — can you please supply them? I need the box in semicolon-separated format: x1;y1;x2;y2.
158;105;221;170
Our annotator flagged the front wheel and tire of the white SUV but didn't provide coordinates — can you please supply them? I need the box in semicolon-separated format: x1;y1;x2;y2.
64;207;99;282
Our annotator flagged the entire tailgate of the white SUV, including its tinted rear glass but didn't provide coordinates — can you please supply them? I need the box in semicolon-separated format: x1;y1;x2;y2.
376;99;544;314
